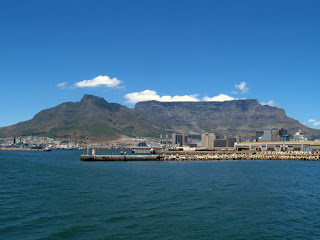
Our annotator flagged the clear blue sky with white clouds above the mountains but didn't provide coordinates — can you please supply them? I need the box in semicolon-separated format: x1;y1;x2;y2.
0;0;320;128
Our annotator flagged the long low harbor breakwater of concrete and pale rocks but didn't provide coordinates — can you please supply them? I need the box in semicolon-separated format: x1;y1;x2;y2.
81;151;320;161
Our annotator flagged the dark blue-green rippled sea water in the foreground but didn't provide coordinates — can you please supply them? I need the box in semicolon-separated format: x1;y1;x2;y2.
0;150;320;240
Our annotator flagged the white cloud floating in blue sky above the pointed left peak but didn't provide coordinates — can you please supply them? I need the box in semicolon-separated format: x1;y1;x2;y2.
73;75;122;88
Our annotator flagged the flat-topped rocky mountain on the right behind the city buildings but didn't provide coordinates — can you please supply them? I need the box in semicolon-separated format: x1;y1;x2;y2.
135;99;319;136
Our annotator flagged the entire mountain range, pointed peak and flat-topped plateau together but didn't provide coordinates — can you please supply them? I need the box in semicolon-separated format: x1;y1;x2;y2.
0;95;320;140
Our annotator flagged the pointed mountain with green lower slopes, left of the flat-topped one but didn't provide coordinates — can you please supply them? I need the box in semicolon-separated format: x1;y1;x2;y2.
0;95;169;139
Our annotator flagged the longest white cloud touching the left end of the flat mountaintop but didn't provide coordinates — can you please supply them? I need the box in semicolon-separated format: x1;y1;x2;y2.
124;89;200;103
